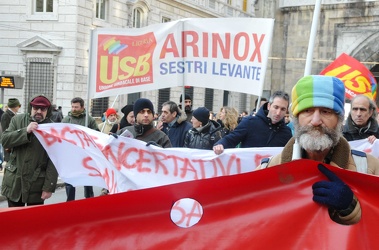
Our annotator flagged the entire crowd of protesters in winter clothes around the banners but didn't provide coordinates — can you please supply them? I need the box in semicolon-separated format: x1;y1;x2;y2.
0;76;379;224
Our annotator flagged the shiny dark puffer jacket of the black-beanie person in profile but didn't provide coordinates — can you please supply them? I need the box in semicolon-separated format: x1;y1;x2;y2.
184;120;221;149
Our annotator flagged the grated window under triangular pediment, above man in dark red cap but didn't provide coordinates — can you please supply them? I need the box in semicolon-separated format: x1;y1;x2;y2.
24;58;54;107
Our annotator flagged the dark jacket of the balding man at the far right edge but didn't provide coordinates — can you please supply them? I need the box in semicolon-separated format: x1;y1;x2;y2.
343;114;379;141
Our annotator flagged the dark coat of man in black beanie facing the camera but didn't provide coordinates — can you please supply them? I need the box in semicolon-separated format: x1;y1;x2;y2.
117;124;172;148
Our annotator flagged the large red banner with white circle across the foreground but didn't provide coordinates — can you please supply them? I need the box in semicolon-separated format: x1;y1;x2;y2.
0;160;379;249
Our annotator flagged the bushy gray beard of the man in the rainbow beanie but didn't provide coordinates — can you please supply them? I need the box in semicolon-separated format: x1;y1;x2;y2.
294;118;342;152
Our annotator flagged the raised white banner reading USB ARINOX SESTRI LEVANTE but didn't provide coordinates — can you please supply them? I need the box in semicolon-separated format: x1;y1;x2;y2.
90;18;274;98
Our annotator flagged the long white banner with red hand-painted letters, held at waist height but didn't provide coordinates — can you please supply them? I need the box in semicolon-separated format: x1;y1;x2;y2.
35;123;379;193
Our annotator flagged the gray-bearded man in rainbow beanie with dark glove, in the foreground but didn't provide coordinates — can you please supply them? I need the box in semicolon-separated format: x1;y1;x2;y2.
258;75;379;225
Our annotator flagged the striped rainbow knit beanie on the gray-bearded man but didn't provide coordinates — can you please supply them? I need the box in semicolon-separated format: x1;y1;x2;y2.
291;75;345;116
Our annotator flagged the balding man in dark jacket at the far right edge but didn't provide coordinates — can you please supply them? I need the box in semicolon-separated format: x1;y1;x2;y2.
343;95;379;144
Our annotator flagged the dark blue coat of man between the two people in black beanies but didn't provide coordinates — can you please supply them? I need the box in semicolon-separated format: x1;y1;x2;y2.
162;112;192;147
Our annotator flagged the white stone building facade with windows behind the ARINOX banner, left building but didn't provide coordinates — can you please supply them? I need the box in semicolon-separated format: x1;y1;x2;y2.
0;0;254;116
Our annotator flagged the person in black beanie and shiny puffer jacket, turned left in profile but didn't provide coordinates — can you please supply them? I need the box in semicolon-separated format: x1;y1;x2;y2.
184;107;221;149
